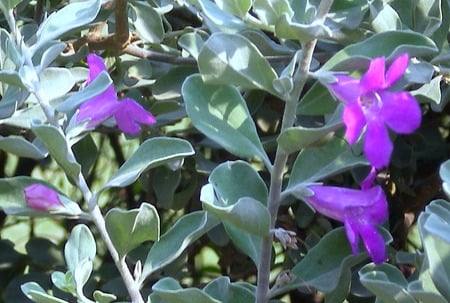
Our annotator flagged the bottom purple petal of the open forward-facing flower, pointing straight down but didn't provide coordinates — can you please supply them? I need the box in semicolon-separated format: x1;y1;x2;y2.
364;120;393;169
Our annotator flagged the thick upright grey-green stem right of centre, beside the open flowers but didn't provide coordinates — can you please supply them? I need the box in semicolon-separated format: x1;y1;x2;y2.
256;0;333;303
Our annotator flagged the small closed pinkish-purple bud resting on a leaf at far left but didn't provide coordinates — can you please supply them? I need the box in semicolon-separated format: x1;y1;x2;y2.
23;183;64;211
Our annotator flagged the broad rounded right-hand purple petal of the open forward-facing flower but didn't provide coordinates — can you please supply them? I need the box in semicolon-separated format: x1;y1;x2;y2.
380;92;422;134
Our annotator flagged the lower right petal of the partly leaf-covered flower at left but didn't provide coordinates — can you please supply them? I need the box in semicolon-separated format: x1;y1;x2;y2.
114;99;156;135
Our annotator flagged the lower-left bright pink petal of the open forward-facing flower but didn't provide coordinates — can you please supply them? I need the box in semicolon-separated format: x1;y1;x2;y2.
342;102;366;144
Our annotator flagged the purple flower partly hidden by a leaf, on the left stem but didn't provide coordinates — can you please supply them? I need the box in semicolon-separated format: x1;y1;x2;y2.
76;54;156;135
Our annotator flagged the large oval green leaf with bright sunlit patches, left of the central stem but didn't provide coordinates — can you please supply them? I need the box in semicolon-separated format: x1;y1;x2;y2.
182;74;270;164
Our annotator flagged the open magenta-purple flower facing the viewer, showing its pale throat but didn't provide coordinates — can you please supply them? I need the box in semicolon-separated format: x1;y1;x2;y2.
328;54;422;168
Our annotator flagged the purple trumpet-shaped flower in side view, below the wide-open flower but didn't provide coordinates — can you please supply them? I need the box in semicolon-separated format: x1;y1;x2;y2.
303;170;388;264
